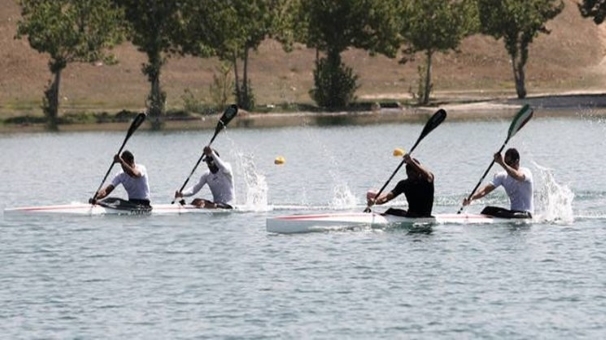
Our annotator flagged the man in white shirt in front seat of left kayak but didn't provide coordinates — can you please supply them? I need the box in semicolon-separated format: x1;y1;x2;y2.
90;150;150;207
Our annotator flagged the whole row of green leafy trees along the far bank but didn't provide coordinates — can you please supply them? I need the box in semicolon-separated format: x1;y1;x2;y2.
17;0;606;129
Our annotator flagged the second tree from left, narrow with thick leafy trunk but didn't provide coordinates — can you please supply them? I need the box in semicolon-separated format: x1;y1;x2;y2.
113;0;182;130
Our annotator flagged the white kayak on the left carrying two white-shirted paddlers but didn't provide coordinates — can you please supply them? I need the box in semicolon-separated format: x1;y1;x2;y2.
4;203;237;216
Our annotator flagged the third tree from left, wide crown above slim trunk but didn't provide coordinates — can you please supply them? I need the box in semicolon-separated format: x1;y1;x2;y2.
180;0;289;110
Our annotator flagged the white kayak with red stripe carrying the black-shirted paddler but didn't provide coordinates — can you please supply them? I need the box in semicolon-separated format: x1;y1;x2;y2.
265;212;532;234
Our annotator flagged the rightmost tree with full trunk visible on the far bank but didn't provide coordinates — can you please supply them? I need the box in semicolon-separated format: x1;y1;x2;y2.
478;0;564;99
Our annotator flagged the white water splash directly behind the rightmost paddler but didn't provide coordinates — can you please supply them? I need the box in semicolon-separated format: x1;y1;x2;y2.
534;163;574;223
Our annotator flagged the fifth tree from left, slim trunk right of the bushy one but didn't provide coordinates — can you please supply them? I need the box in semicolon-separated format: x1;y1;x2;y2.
400;0;476;105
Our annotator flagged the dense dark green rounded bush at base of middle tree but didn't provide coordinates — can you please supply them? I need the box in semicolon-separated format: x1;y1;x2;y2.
309;54;358;110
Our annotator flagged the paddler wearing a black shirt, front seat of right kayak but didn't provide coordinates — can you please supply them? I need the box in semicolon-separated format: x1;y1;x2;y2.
367;154;434;217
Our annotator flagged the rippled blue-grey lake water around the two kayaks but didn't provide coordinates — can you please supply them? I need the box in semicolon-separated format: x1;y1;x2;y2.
0;112;606;339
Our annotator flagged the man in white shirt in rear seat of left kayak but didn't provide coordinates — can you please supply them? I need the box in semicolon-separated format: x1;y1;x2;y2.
175;146;236;209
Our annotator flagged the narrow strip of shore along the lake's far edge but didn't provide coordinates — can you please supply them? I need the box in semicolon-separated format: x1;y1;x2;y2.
0;93;606;133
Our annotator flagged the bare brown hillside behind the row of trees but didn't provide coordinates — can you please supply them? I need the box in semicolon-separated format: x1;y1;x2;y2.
0;0;606;117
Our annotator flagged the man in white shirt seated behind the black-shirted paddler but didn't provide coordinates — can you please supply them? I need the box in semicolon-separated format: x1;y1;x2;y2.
463;148;534;218
